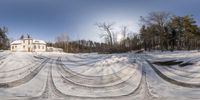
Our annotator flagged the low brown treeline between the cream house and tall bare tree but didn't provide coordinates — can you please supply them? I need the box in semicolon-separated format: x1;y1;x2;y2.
50;34;108;53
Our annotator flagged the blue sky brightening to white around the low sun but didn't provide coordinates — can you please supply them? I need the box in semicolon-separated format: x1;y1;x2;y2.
0;0;200;41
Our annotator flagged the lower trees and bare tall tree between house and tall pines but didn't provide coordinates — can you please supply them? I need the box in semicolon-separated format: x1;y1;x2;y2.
51;23;141;53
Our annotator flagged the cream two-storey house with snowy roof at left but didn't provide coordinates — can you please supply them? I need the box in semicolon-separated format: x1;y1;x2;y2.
10;35;46;52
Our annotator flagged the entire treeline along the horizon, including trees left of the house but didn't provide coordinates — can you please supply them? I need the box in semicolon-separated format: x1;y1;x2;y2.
0;12;200;53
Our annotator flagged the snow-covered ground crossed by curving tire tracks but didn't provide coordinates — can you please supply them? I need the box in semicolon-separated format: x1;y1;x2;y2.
0;51;200;100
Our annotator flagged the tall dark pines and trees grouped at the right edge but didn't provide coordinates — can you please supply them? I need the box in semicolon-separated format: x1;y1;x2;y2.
140;12;200;51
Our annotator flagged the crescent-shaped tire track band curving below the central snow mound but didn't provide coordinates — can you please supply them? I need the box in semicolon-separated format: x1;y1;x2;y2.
58;57;136;87
